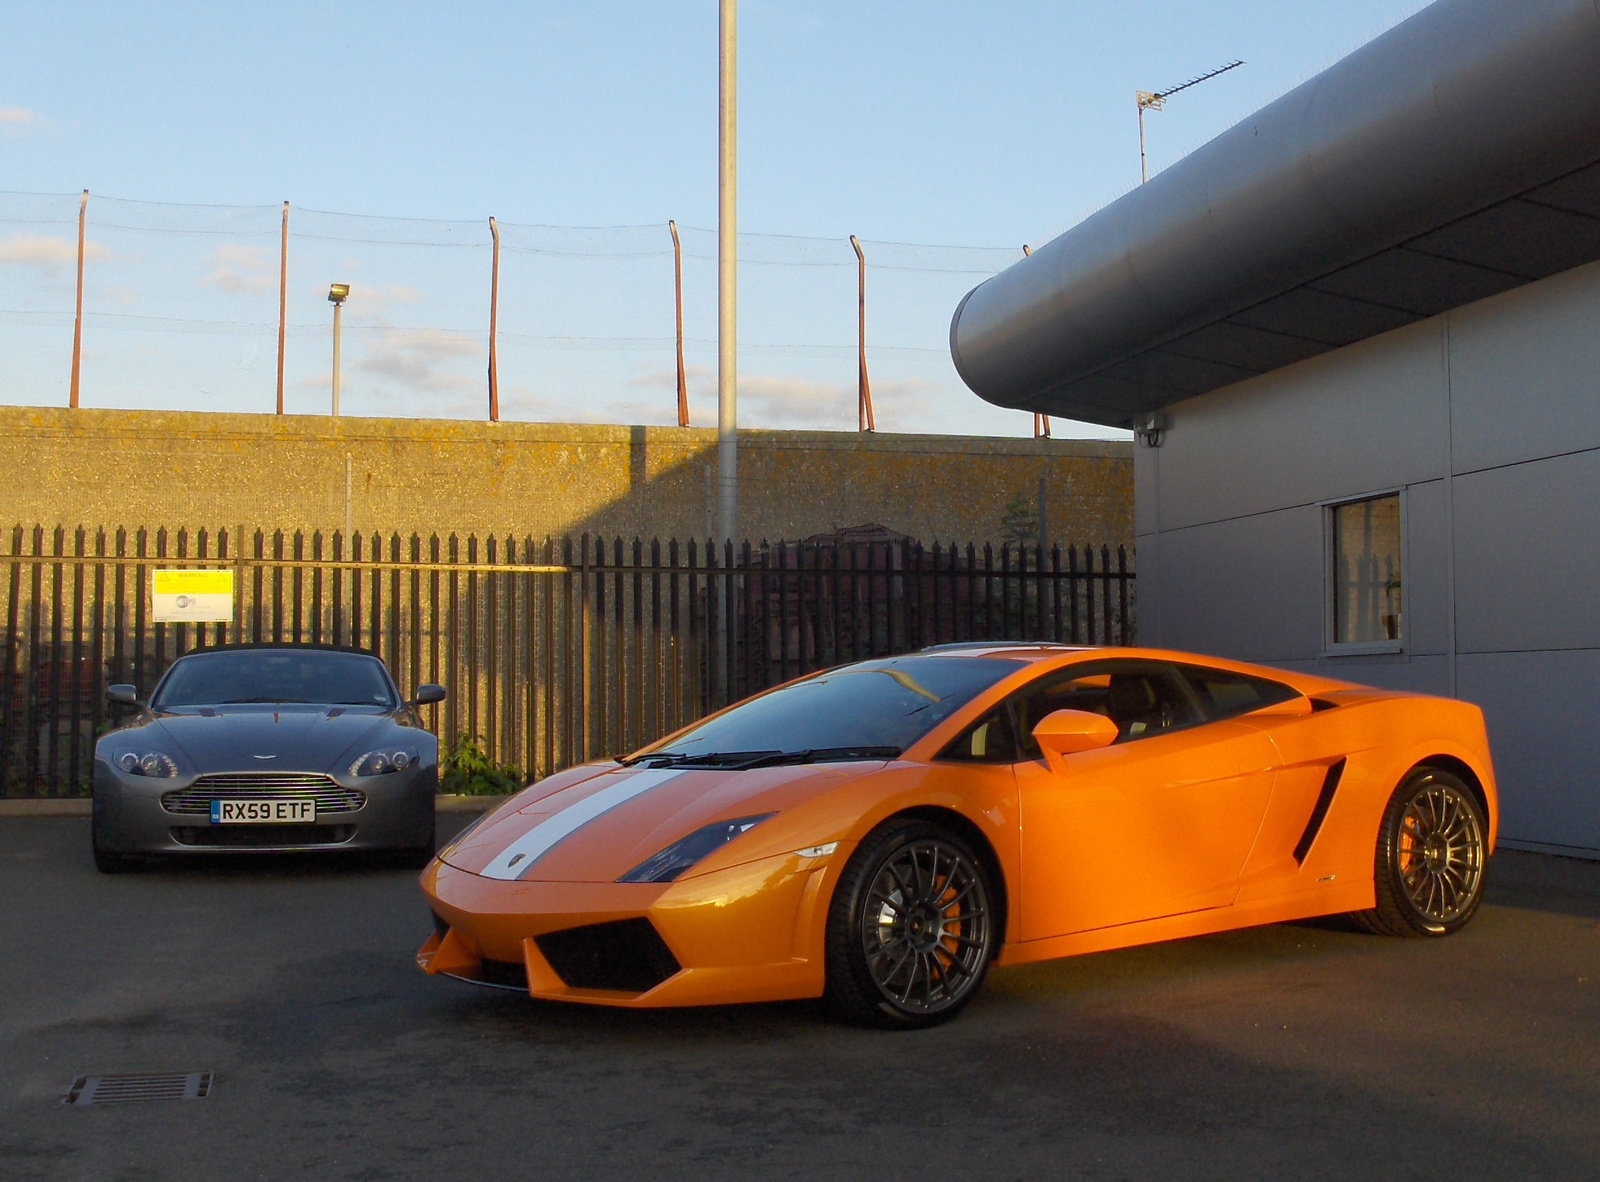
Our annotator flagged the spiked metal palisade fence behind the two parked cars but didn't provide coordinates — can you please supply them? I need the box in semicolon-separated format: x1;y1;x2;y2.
0;526;1136;795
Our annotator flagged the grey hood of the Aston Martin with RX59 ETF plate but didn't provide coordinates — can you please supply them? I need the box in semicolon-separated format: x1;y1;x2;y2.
139;707;394;774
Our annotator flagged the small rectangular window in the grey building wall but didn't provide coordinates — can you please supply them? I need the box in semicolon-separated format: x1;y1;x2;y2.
1328;493;1402;649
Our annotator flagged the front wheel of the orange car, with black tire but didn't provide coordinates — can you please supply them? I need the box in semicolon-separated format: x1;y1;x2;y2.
822;819;998;1030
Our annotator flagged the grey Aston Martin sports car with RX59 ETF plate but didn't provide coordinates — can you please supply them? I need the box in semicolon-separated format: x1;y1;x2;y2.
93;645;445;873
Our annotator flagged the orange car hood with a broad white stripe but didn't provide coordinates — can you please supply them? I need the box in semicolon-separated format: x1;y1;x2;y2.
440;761;885;883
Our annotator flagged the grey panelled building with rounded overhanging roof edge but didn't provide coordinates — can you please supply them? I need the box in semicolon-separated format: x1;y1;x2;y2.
950;0;1600;857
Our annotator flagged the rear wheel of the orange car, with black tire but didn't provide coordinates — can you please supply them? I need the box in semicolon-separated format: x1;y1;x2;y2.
1355;768;1488;937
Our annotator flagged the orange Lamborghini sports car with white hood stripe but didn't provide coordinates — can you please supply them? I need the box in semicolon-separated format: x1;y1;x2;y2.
418;643;1498;1027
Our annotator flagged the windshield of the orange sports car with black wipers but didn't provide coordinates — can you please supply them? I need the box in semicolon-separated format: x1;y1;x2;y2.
637;656;1018;768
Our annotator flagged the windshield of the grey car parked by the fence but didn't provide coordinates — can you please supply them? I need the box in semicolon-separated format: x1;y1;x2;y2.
150;649;395;710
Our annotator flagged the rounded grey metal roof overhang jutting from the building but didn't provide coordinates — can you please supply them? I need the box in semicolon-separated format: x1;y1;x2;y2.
950;0;1600;424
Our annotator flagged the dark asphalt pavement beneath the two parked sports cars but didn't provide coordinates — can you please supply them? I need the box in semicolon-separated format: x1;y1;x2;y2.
0;816;1600;1182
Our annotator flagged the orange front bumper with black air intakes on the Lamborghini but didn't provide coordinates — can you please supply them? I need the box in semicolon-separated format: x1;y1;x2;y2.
416;845;850;1008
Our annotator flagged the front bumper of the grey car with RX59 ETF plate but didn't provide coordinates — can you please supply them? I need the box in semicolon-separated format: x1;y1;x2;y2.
93;760;437;854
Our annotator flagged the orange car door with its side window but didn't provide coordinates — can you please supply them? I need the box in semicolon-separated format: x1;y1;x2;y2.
1013;659;1277;940
